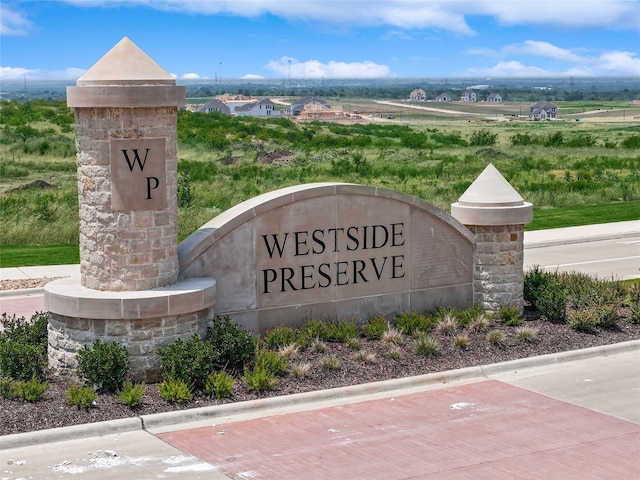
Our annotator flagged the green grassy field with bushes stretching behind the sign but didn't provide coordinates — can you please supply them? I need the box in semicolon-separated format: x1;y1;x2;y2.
0;99;640;266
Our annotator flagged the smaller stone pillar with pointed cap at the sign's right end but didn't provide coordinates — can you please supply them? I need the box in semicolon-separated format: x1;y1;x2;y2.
451;164;533;311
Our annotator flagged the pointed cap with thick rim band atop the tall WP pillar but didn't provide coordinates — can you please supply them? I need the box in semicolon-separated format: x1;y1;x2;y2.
67;37;185;107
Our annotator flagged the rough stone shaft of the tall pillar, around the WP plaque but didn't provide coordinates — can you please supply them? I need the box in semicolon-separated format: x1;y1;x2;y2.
75;106;179;291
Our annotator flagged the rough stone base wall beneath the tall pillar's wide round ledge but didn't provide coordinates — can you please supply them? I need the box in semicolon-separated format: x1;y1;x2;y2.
48;307;213;382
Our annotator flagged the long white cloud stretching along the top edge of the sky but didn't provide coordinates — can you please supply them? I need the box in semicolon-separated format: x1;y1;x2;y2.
57;0;640;31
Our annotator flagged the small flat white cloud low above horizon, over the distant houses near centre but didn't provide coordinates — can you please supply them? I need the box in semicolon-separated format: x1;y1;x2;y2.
265;57;392;78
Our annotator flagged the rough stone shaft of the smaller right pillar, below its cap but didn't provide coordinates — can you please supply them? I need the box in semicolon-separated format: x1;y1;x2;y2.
467;225;524;311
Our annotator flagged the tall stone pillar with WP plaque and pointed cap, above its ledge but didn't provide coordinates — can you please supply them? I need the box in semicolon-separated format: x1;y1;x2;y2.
67;37;185;291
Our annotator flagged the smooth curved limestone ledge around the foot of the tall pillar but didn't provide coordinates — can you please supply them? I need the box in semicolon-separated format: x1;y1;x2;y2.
44;277;216;320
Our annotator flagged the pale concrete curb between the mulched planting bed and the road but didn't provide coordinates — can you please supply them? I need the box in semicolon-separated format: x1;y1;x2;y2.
0;340;640;450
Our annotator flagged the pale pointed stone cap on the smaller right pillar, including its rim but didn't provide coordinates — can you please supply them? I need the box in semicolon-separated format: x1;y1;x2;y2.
451;164;533;225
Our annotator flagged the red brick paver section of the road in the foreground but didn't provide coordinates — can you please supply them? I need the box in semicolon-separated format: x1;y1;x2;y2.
158;381;640;480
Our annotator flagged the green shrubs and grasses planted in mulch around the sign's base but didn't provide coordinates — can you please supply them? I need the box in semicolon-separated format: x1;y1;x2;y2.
0;267;640;408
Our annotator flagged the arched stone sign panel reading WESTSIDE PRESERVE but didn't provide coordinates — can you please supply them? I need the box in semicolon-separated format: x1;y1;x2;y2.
178;183;474;331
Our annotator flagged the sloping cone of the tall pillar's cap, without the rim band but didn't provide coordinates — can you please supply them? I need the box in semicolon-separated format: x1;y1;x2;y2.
76;37;176;86
